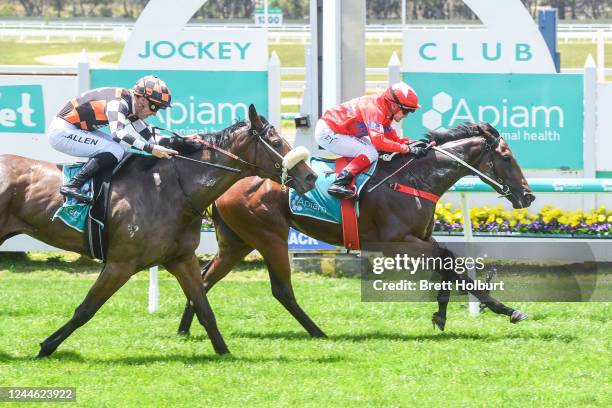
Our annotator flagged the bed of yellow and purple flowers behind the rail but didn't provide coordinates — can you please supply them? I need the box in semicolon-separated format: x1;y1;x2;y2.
434;203;612;237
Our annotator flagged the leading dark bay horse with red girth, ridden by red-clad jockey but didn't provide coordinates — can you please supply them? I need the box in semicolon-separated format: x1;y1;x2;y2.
179;123;535;337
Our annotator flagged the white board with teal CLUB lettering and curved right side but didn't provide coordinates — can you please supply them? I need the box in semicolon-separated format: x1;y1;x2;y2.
402;0;556;73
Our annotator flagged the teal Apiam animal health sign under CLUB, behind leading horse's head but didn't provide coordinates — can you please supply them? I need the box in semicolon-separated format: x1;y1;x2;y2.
403;73;583;170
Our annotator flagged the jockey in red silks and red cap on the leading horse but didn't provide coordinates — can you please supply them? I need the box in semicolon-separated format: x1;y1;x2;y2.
315;82;427;198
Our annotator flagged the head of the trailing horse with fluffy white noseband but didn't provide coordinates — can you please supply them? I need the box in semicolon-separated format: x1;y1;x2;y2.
243;105;317;194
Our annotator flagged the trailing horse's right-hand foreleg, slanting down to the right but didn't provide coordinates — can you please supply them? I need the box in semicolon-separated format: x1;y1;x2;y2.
164;254;229;354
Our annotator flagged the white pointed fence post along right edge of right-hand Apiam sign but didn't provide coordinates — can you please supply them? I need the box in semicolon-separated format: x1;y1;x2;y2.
582;54;597;211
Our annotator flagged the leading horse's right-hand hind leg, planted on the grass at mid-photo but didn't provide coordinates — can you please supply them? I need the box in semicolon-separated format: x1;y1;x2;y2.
262;242;327;337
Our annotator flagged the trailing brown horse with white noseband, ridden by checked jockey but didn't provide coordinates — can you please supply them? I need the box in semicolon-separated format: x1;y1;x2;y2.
0;105;316;357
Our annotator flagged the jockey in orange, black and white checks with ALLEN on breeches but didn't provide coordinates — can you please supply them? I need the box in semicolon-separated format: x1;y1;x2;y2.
48;75;178;204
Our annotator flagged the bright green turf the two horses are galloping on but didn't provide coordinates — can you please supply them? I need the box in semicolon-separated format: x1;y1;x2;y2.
0;256;612;407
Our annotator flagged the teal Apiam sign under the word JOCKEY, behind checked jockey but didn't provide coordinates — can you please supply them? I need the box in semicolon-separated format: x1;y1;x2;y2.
91;69;268;135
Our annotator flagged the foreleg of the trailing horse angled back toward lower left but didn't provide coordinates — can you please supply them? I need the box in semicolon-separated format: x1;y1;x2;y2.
38;264;135;357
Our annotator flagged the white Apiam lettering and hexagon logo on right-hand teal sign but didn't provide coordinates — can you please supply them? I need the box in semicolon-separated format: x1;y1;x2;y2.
421;92;565;131
